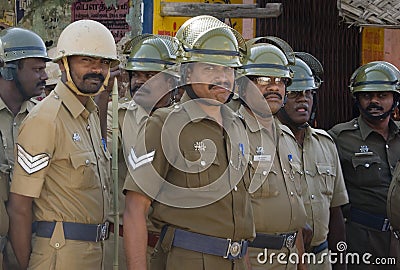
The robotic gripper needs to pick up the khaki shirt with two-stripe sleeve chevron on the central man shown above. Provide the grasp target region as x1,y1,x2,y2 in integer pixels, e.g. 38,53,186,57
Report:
124,96,254,241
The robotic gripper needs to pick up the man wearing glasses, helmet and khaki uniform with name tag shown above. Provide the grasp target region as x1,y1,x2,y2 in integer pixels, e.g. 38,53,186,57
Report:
238,37,306,269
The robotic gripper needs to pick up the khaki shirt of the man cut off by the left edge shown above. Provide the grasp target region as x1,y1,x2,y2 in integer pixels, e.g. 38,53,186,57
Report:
0,98,37,236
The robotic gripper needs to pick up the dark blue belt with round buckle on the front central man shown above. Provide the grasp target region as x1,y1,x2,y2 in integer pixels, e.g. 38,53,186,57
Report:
161,229,248,260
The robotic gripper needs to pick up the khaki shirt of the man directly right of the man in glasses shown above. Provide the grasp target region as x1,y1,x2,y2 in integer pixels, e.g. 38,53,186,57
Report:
299,127,349,246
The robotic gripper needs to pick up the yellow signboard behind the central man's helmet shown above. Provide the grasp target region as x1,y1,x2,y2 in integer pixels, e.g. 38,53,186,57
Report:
153,0,254,39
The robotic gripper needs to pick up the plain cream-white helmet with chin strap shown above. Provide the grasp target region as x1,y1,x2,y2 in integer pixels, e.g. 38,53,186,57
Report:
53,20,119,96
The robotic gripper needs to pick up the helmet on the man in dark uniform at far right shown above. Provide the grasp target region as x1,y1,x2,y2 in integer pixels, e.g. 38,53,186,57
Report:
349,61,400,96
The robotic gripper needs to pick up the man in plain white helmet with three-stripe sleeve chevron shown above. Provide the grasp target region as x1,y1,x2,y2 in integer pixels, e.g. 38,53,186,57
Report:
8,20,118,269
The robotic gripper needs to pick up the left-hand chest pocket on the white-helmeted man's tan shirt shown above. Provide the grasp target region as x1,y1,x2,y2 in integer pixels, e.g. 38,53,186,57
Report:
70,151,99,189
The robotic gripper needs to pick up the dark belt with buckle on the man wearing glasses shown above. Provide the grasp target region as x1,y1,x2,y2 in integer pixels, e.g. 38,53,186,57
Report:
249,232,297,250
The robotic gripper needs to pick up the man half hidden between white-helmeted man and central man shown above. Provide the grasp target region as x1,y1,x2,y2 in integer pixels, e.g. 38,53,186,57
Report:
105,34,179,269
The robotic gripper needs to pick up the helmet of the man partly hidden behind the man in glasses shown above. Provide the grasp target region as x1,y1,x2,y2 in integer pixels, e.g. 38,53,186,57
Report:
287,52,324,91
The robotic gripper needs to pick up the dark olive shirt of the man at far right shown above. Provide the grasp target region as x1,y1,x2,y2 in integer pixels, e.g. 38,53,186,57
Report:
329,117,400,216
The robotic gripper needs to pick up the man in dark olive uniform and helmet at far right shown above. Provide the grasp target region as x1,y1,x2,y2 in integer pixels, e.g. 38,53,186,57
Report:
329,61,400,269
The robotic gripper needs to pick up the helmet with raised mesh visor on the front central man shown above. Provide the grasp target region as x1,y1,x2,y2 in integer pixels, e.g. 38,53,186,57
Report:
175,15,246,67
